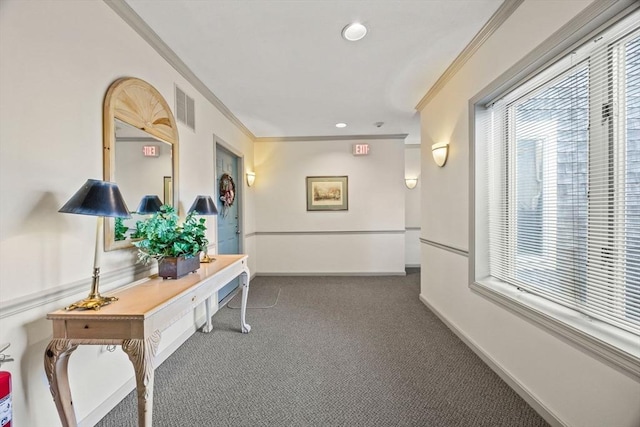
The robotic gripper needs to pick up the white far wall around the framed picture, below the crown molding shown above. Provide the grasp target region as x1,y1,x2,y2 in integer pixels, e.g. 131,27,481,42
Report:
255,139,405,274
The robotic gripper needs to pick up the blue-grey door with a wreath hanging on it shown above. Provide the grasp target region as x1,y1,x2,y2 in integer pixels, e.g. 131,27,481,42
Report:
216,144,241,302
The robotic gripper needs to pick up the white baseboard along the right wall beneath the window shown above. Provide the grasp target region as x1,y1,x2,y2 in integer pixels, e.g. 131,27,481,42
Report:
420,294,567,427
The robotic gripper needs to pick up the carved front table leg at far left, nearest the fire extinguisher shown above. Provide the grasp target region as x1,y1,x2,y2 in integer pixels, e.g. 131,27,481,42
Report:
44,338,78,427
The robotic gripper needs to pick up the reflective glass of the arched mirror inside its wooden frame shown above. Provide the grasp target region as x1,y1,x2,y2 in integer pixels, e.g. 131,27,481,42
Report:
113,119,173,242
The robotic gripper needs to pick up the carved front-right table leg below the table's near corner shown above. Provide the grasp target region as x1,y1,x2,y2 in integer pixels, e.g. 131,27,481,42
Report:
122,331,160,427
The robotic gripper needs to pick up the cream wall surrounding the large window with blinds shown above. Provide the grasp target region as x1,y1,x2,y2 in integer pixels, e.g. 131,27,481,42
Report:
421,0,640,427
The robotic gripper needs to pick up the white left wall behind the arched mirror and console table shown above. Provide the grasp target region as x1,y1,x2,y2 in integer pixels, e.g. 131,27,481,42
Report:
0,0,255,427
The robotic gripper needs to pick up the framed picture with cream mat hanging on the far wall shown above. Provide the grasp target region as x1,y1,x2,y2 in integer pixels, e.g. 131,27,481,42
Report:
307,176,349,211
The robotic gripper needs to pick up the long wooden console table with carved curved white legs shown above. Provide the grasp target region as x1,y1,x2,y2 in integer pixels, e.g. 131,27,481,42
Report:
44,255,251,427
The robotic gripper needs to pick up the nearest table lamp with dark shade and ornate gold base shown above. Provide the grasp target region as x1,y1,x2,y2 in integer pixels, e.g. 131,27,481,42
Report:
58,179,131,310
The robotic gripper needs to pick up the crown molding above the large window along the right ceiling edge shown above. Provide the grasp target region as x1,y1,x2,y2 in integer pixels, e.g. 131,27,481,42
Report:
416,0,524,111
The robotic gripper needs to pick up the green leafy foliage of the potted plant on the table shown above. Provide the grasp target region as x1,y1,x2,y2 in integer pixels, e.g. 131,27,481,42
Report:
133,205,209,264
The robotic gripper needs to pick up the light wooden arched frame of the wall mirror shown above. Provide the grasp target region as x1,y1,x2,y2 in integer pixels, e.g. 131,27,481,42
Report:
102,77,179,251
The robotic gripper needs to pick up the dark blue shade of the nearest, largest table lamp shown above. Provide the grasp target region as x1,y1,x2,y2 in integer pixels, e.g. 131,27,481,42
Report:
58,179,131,218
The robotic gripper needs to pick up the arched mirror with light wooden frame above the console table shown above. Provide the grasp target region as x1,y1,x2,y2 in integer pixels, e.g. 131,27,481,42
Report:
103,77,178,251
